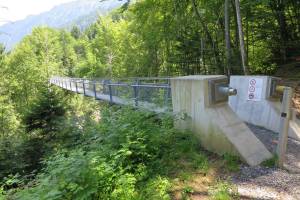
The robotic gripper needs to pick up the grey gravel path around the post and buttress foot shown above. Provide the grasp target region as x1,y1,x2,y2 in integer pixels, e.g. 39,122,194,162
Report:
233,125,300,200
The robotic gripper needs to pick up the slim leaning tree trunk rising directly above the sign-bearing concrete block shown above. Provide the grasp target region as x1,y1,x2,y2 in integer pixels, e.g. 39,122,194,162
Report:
235,0,249,75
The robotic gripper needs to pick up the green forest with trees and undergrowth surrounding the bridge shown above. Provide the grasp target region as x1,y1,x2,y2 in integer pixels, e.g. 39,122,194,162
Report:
0,0,300,200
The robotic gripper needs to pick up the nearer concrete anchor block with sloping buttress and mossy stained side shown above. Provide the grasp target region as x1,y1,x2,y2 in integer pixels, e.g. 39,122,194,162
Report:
171,76,272,165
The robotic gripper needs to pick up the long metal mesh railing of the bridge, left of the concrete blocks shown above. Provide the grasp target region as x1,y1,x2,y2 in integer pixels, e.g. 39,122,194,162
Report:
50,77,172,112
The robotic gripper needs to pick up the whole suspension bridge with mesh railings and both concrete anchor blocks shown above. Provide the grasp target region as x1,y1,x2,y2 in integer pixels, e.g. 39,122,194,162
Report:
50,75,300,168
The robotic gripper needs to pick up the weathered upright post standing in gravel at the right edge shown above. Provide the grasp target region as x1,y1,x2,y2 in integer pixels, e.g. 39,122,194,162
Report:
277,87,293,168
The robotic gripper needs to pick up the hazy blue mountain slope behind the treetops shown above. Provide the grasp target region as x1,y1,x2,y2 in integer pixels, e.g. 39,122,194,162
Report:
0,0,126,50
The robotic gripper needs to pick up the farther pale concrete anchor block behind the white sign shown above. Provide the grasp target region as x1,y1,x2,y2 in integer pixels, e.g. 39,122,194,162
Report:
229,76,300,140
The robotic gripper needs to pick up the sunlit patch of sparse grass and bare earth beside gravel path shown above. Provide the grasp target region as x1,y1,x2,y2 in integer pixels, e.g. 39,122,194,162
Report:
171,153,240,200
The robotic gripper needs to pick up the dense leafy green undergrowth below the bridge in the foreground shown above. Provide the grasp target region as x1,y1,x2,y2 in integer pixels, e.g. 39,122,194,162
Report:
0,98,239,200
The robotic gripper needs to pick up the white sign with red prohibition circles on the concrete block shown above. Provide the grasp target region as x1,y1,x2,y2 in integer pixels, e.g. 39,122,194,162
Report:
248,78,263,101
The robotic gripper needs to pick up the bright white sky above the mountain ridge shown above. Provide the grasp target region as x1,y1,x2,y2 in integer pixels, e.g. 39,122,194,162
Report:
0,0,74,25
